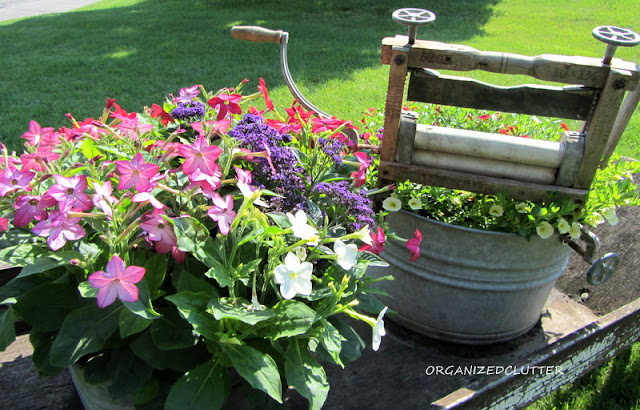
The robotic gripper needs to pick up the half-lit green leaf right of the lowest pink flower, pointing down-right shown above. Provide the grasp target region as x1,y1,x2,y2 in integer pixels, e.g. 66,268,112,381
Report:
166,292,220,341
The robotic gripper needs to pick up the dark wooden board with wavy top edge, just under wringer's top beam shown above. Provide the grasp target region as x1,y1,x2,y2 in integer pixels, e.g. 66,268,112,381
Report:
407,70,596,121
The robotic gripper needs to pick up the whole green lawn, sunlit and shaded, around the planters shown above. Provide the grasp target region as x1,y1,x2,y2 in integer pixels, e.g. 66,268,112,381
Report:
0,0,640,409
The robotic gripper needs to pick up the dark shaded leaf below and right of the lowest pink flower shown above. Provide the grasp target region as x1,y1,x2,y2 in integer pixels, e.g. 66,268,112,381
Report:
151,306,199,350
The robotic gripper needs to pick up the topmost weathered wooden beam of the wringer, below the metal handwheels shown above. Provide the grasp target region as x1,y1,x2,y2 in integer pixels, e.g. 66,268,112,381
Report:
382,36,640,90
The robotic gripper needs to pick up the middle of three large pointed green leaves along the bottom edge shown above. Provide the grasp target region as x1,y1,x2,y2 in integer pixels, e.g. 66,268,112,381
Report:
224,344,282,403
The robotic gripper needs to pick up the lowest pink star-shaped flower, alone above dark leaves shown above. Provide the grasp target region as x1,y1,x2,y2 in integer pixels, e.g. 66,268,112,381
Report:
87,255,145,308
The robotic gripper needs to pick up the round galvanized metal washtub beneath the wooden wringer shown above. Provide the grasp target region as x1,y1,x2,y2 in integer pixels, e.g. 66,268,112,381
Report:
368,211,571,344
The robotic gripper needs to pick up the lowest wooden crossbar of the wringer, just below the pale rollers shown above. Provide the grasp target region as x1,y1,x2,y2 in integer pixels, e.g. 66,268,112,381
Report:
378,161,588,202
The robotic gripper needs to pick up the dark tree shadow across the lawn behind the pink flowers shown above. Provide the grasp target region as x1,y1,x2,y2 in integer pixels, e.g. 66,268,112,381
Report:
0,0,498,149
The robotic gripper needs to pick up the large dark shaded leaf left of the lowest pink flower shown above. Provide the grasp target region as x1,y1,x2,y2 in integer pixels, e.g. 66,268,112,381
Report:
15,282,81,332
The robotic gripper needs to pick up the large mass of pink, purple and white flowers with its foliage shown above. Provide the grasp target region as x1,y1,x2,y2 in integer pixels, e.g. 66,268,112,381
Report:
0,80,416,408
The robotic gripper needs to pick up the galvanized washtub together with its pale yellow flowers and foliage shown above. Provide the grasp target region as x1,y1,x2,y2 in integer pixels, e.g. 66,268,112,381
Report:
365,104,640,344
